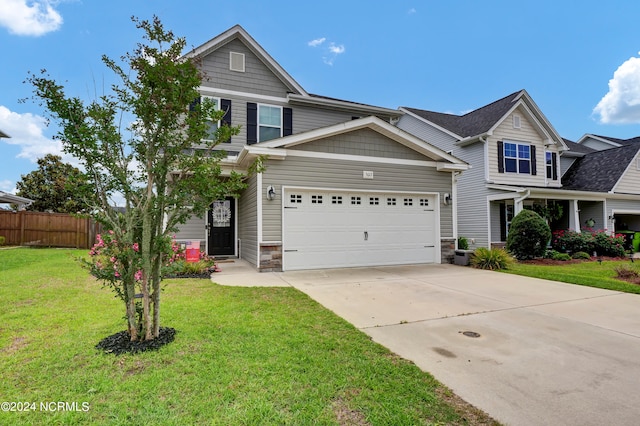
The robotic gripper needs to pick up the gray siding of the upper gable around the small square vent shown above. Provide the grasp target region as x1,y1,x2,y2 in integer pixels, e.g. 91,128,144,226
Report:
202,39,292,98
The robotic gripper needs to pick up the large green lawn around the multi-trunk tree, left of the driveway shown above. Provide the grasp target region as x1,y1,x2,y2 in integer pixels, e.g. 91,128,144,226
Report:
0,248,493,425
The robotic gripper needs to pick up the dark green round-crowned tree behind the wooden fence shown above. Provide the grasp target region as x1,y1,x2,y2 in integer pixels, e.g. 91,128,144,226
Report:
16,154,93,213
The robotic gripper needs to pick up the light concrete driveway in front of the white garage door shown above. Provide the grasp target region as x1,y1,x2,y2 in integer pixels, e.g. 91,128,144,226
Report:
213,261,640,425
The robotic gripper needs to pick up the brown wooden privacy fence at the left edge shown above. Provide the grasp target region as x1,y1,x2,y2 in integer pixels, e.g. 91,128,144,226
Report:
0,211,100,248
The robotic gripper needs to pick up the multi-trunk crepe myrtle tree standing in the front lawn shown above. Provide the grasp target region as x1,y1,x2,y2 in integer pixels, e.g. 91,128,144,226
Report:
27,17,262,341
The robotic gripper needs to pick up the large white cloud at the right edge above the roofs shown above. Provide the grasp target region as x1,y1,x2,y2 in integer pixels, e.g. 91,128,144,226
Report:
593,52,640,124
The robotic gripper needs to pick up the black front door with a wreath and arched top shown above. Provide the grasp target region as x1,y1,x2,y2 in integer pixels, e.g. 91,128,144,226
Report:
207,198,236,256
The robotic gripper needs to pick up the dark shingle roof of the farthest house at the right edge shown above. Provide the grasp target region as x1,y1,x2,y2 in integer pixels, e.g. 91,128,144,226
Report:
562,143,640,192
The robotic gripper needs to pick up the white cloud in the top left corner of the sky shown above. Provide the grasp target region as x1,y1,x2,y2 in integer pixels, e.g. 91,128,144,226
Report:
0,0,62,37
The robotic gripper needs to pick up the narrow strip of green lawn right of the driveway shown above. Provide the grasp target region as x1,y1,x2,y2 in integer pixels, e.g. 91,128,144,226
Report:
502,260,640,294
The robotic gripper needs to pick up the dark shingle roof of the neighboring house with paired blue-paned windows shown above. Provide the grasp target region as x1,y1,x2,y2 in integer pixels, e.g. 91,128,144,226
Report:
403,90,523,138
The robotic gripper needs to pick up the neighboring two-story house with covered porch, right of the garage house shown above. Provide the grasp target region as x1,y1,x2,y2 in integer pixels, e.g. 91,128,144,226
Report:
398,90,624,248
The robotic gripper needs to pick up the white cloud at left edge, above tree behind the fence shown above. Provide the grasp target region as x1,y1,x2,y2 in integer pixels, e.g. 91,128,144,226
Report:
0,105,65,163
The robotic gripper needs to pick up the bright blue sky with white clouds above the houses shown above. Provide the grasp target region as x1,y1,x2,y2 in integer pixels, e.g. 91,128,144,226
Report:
0,0,640,192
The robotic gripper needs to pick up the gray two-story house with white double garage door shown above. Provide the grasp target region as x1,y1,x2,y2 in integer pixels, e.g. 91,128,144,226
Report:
176,26,468,270
